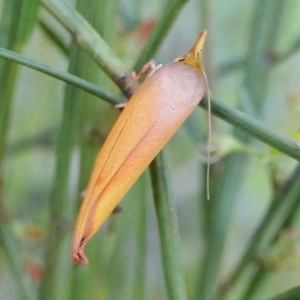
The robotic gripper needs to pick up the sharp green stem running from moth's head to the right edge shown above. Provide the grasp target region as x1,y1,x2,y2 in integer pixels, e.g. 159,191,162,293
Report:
199,97,300,161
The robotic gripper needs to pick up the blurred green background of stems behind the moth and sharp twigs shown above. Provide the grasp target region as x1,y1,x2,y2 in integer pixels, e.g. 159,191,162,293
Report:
0,0,300,300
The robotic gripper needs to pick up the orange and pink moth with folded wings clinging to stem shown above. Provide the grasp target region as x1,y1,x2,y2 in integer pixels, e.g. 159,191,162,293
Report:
72,31,208,265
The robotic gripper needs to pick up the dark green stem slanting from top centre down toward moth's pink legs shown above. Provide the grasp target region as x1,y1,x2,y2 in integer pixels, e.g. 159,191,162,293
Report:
133,0,187,71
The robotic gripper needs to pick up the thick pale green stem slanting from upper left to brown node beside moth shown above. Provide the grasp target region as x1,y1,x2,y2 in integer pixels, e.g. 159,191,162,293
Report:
40,0,137,96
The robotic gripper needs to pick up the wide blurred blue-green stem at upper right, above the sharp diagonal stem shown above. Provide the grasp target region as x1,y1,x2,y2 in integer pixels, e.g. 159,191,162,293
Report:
242,0,286,116
